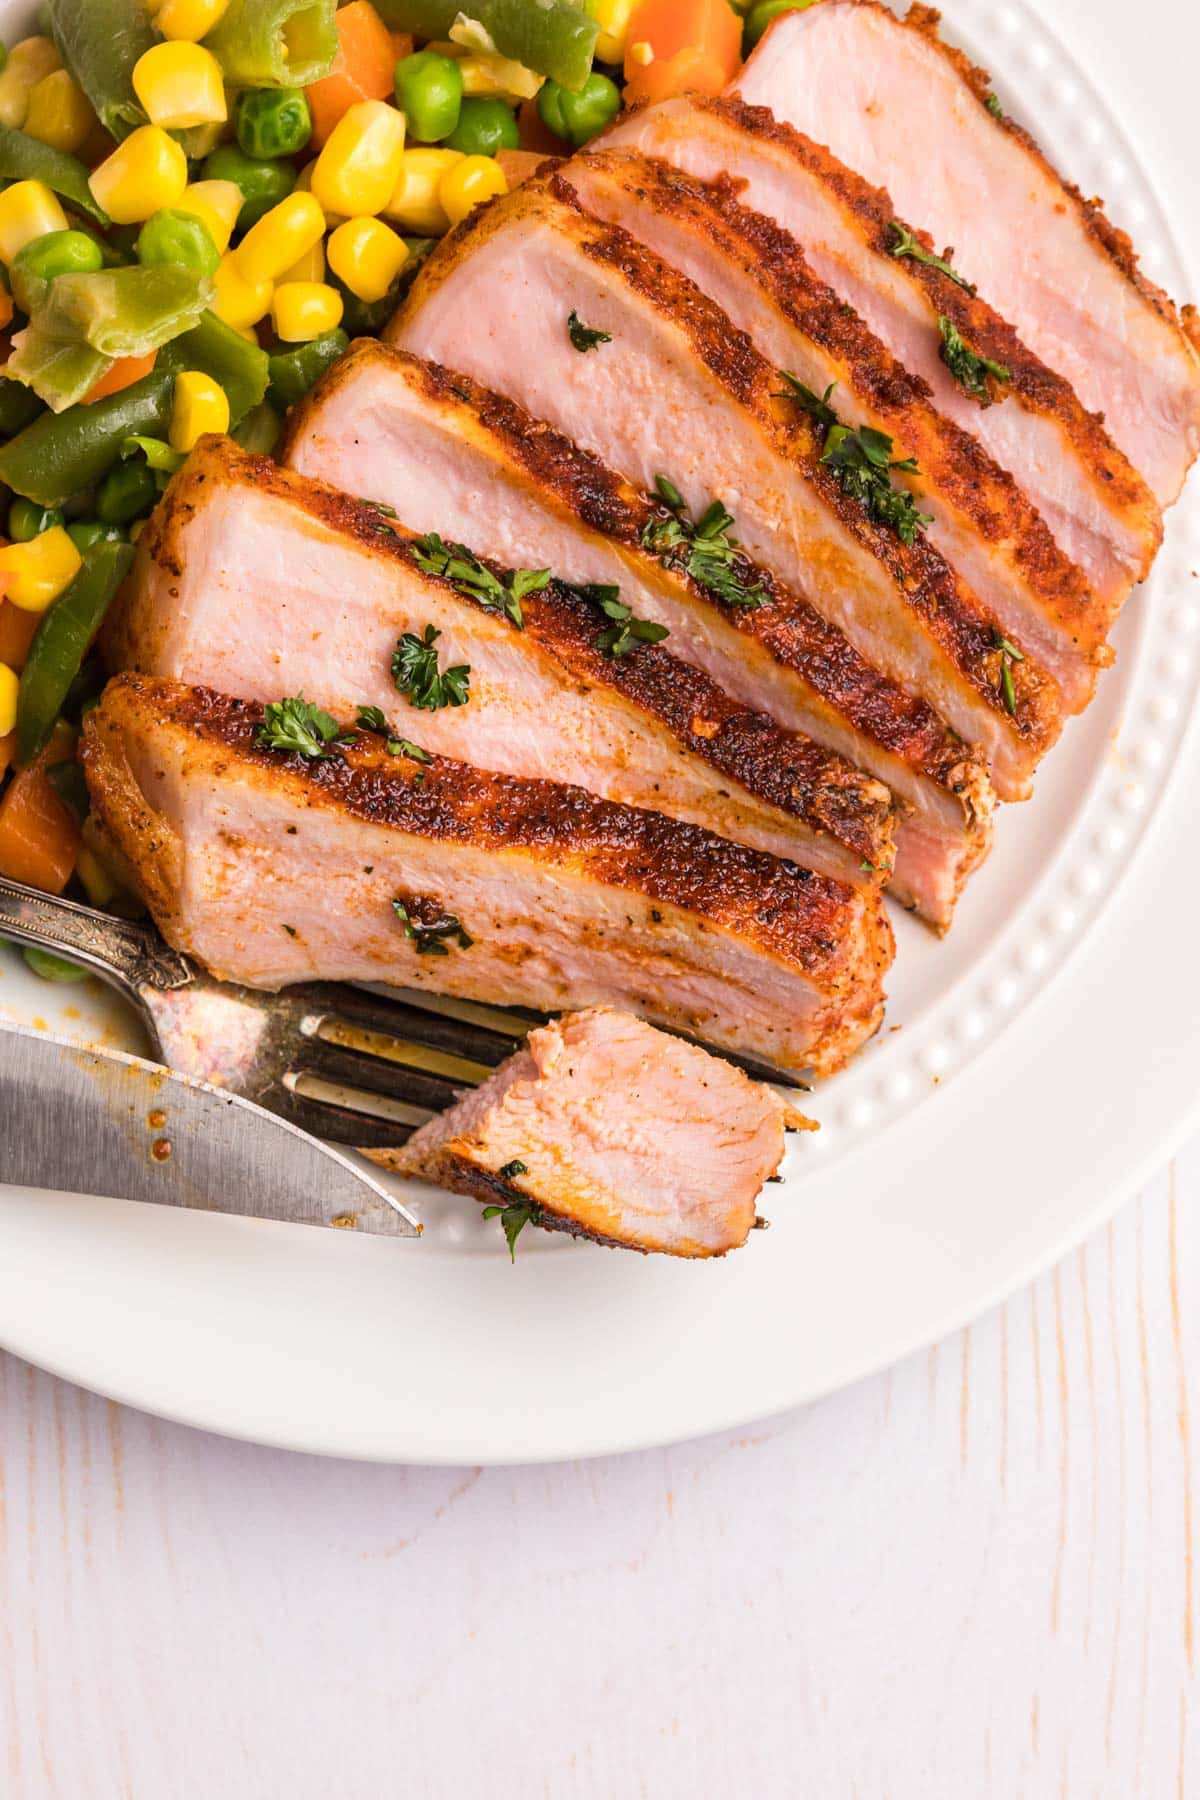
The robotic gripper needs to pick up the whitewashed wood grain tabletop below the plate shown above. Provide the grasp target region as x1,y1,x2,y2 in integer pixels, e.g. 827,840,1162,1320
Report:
0,1145,1200,1800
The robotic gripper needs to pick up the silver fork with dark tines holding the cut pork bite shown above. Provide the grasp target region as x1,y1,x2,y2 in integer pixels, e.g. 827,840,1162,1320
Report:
0,877,804,1150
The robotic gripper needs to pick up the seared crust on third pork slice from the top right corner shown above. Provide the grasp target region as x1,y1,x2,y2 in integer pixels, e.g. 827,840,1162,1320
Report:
563,149,1112,668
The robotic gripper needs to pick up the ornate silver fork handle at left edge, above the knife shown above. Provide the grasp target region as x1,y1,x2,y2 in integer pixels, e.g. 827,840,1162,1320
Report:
0,875,194,999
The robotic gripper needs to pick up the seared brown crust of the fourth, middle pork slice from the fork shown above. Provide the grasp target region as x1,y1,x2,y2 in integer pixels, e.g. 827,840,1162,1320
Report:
413,186,1061,761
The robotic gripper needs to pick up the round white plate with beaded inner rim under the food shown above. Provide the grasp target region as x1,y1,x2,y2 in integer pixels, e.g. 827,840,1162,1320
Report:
0,0,1200,1463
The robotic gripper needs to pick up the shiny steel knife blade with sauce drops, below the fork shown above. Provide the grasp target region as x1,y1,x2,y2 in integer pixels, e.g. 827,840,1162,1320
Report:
0,1024,421,1237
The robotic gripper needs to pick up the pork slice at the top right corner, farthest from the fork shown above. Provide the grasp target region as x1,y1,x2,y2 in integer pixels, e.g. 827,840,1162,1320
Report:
734,0,1200,506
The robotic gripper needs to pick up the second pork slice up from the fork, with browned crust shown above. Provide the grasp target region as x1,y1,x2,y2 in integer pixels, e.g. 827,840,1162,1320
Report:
104,437,894,882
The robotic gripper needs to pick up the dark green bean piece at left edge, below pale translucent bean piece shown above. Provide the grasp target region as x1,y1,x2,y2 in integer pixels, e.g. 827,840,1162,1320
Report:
0,365,173,506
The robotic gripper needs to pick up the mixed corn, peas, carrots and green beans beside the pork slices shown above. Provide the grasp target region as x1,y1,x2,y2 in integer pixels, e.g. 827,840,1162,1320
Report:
0,0,810,977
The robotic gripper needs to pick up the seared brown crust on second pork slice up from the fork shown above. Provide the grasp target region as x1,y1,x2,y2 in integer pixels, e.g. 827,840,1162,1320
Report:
129,437,896,871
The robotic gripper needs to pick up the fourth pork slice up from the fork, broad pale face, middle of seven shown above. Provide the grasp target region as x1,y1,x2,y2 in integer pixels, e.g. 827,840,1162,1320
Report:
389,175,1061,799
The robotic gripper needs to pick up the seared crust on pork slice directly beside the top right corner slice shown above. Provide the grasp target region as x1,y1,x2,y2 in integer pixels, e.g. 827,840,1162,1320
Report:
694,91,1162,565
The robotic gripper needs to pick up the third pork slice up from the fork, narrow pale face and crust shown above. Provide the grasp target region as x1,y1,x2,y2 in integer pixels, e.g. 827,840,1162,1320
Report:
284,338,993,929
